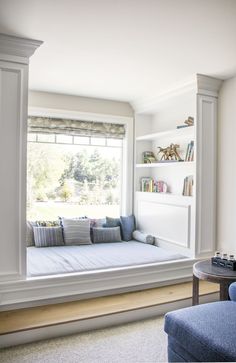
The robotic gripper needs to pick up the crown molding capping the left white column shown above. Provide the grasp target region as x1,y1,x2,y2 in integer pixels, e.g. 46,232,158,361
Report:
0,33,43,64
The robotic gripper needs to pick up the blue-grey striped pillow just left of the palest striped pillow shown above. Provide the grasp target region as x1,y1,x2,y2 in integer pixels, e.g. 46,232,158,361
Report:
33,227,64,247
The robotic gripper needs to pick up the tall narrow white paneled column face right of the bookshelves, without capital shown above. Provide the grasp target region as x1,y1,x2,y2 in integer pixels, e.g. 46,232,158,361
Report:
196,95,217,256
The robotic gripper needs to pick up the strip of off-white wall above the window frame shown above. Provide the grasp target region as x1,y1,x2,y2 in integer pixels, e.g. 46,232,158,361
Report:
29,91,133,117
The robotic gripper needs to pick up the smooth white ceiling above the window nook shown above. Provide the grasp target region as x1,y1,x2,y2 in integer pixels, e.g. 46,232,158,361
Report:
0,0,236,111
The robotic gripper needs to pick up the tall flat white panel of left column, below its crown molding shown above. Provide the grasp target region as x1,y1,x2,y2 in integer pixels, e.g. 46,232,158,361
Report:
0,62,24,279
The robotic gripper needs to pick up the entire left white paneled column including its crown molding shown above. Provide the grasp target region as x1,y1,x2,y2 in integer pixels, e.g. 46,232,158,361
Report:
0,34,41,281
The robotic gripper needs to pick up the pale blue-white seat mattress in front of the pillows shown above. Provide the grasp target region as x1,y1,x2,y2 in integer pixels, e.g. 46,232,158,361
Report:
27,241,184,277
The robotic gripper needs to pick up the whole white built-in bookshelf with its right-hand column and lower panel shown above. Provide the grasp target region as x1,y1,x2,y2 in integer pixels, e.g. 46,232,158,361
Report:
134,75,221,258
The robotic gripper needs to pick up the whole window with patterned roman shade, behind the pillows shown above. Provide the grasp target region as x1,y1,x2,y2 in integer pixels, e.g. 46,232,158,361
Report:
27,117,124,221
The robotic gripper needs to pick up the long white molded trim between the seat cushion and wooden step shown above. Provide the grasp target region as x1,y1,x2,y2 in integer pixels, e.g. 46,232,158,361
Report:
0,259,196,310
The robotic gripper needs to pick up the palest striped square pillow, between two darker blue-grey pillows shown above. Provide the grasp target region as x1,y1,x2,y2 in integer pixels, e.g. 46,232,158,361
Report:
61,218,92,245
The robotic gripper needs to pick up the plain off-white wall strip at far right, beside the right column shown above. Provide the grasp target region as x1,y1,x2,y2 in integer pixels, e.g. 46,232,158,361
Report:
217,77,236,254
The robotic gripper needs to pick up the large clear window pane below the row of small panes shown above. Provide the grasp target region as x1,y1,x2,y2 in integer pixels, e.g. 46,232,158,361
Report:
27,144,122,221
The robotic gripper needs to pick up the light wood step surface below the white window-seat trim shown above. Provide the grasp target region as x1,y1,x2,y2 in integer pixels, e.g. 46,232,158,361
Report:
0,281,219,335
